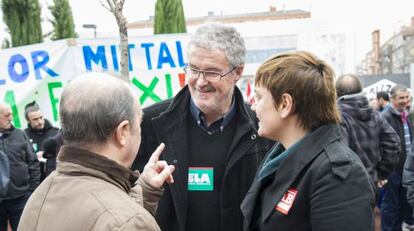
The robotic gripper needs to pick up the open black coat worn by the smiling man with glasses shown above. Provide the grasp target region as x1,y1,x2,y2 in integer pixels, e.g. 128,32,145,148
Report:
133,86,273,231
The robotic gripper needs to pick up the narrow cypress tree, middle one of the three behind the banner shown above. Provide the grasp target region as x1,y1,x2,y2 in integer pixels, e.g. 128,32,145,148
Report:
49,0,77,40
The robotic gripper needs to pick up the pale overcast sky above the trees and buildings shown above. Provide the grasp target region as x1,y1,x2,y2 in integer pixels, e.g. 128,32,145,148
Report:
0,0,414,66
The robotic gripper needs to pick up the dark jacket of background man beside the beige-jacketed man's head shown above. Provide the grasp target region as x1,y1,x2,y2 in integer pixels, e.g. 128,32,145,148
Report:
24,119,59,152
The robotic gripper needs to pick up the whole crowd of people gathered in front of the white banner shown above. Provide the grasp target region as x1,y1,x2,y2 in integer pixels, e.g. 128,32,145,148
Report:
0,23,414,231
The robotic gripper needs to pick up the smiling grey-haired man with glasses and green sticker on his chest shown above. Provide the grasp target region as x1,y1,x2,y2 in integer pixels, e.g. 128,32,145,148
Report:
133,23,272,231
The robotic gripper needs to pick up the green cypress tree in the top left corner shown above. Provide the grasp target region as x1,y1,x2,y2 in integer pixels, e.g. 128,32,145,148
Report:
1,0,43,47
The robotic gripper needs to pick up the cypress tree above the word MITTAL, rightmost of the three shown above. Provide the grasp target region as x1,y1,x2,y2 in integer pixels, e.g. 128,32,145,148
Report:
154,0,187,34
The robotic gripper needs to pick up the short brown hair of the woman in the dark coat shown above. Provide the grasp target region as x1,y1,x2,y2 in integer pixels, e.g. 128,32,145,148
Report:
254,51,340,130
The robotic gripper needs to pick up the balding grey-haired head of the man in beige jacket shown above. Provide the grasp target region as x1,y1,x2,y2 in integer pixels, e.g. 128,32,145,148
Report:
60,73,141,144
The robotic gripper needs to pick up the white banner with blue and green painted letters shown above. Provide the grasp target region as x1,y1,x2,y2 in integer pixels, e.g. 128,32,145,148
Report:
0,34,189,127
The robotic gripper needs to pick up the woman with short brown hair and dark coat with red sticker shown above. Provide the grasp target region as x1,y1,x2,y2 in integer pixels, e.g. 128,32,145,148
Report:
241,51,375,231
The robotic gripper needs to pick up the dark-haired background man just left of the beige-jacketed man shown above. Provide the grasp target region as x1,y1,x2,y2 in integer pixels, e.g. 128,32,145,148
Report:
24,101,59,181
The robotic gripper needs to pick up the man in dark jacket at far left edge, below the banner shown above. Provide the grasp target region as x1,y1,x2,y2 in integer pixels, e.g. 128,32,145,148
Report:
0,103,40,231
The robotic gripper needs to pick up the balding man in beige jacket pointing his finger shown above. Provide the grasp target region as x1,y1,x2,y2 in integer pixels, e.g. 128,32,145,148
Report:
19,73,174,231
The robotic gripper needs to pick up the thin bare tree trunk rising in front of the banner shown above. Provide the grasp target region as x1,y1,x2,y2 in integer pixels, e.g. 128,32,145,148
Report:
100,0,129,81
